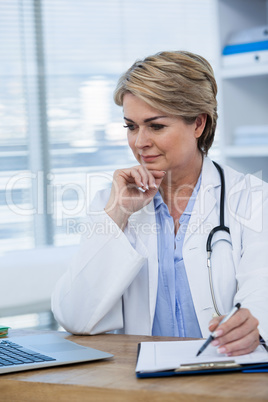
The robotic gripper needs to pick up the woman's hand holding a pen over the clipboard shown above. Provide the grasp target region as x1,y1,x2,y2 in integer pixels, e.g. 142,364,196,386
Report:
209,308,259,356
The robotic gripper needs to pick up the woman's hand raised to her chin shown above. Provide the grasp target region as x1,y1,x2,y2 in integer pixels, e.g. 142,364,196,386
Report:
105,165,166,230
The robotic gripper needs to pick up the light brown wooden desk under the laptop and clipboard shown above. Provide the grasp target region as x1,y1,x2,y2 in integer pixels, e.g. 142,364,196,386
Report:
0,331,268,402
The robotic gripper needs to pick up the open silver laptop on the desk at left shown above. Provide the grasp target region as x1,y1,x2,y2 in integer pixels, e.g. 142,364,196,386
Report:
0,333,113,374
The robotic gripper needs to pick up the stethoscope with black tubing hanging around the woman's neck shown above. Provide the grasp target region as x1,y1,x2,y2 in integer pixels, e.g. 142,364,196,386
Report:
206,161,230,316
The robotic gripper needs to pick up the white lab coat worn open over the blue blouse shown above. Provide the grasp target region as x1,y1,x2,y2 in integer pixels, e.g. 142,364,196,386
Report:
52,158,268,341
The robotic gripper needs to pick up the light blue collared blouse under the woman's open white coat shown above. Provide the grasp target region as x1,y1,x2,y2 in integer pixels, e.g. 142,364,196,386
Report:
152,175,202,338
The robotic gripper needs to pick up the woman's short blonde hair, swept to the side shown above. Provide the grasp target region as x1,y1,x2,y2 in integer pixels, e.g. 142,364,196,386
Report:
114,51,218,155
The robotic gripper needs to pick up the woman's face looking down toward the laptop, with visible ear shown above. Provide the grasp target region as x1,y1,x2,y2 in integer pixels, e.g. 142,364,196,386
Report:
123,93,206,176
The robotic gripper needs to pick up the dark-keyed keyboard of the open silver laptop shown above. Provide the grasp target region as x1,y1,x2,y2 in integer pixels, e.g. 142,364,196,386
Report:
0,340,56,367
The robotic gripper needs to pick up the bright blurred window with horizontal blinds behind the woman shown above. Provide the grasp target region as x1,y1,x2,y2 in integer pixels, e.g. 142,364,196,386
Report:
0,0,217,249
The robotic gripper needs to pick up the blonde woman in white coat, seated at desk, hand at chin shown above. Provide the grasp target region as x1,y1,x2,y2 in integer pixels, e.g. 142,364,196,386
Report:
52,51,268,356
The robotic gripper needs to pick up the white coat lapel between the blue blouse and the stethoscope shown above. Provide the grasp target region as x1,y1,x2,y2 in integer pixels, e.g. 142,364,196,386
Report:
183,158,221,337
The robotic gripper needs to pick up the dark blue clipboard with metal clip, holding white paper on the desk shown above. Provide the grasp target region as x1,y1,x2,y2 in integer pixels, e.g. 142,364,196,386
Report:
136,341,268,378
